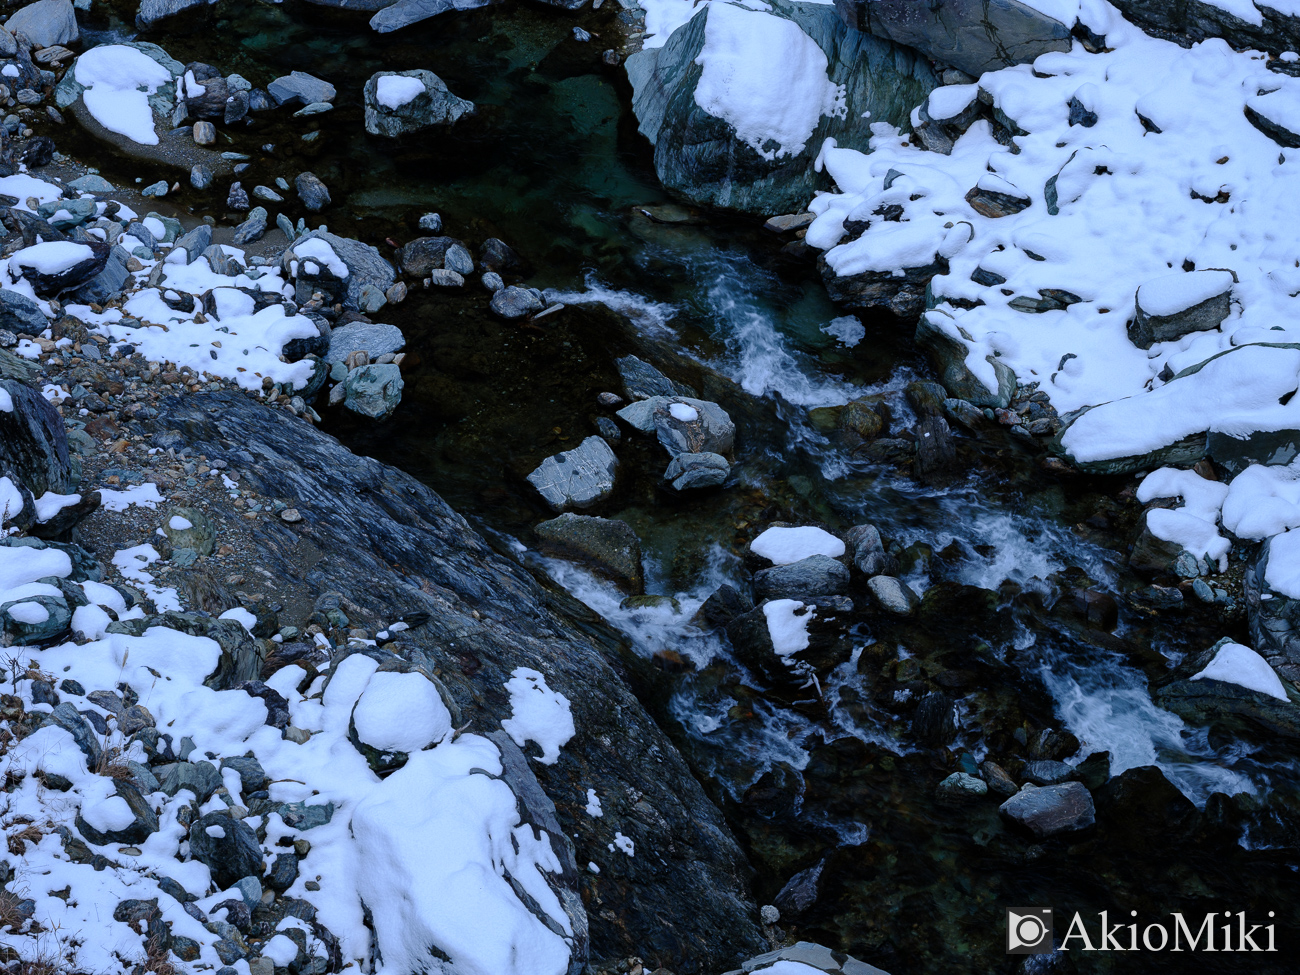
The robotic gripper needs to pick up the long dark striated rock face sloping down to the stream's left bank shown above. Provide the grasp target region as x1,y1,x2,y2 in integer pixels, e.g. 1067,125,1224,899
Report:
147,393,766,971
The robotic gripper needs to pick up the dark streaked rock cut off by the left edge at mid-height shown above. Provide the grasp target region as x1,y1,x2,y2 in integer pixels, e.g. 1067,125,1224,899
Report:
0,380,75,498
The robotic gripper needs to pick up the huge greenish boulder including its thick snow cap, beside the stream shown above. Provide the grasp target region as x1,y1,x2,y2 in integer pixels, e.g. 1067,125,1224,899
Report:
627,0,937,216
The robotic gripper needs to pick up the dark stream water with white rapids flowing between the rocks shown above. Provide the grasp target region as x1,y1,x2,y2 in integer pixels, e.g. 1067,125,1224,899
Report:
65,0,1300,975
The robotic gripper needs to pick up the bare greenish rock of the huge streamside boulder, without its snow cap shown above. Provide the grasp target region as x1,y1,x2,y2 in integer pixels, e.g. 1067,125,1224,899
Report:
627,0,939,216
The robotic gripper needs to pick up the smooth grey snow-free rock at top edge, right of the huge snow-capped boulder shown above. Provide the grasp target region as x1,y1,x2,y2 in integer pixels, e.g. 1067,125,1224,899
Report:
835,0,1074,78
